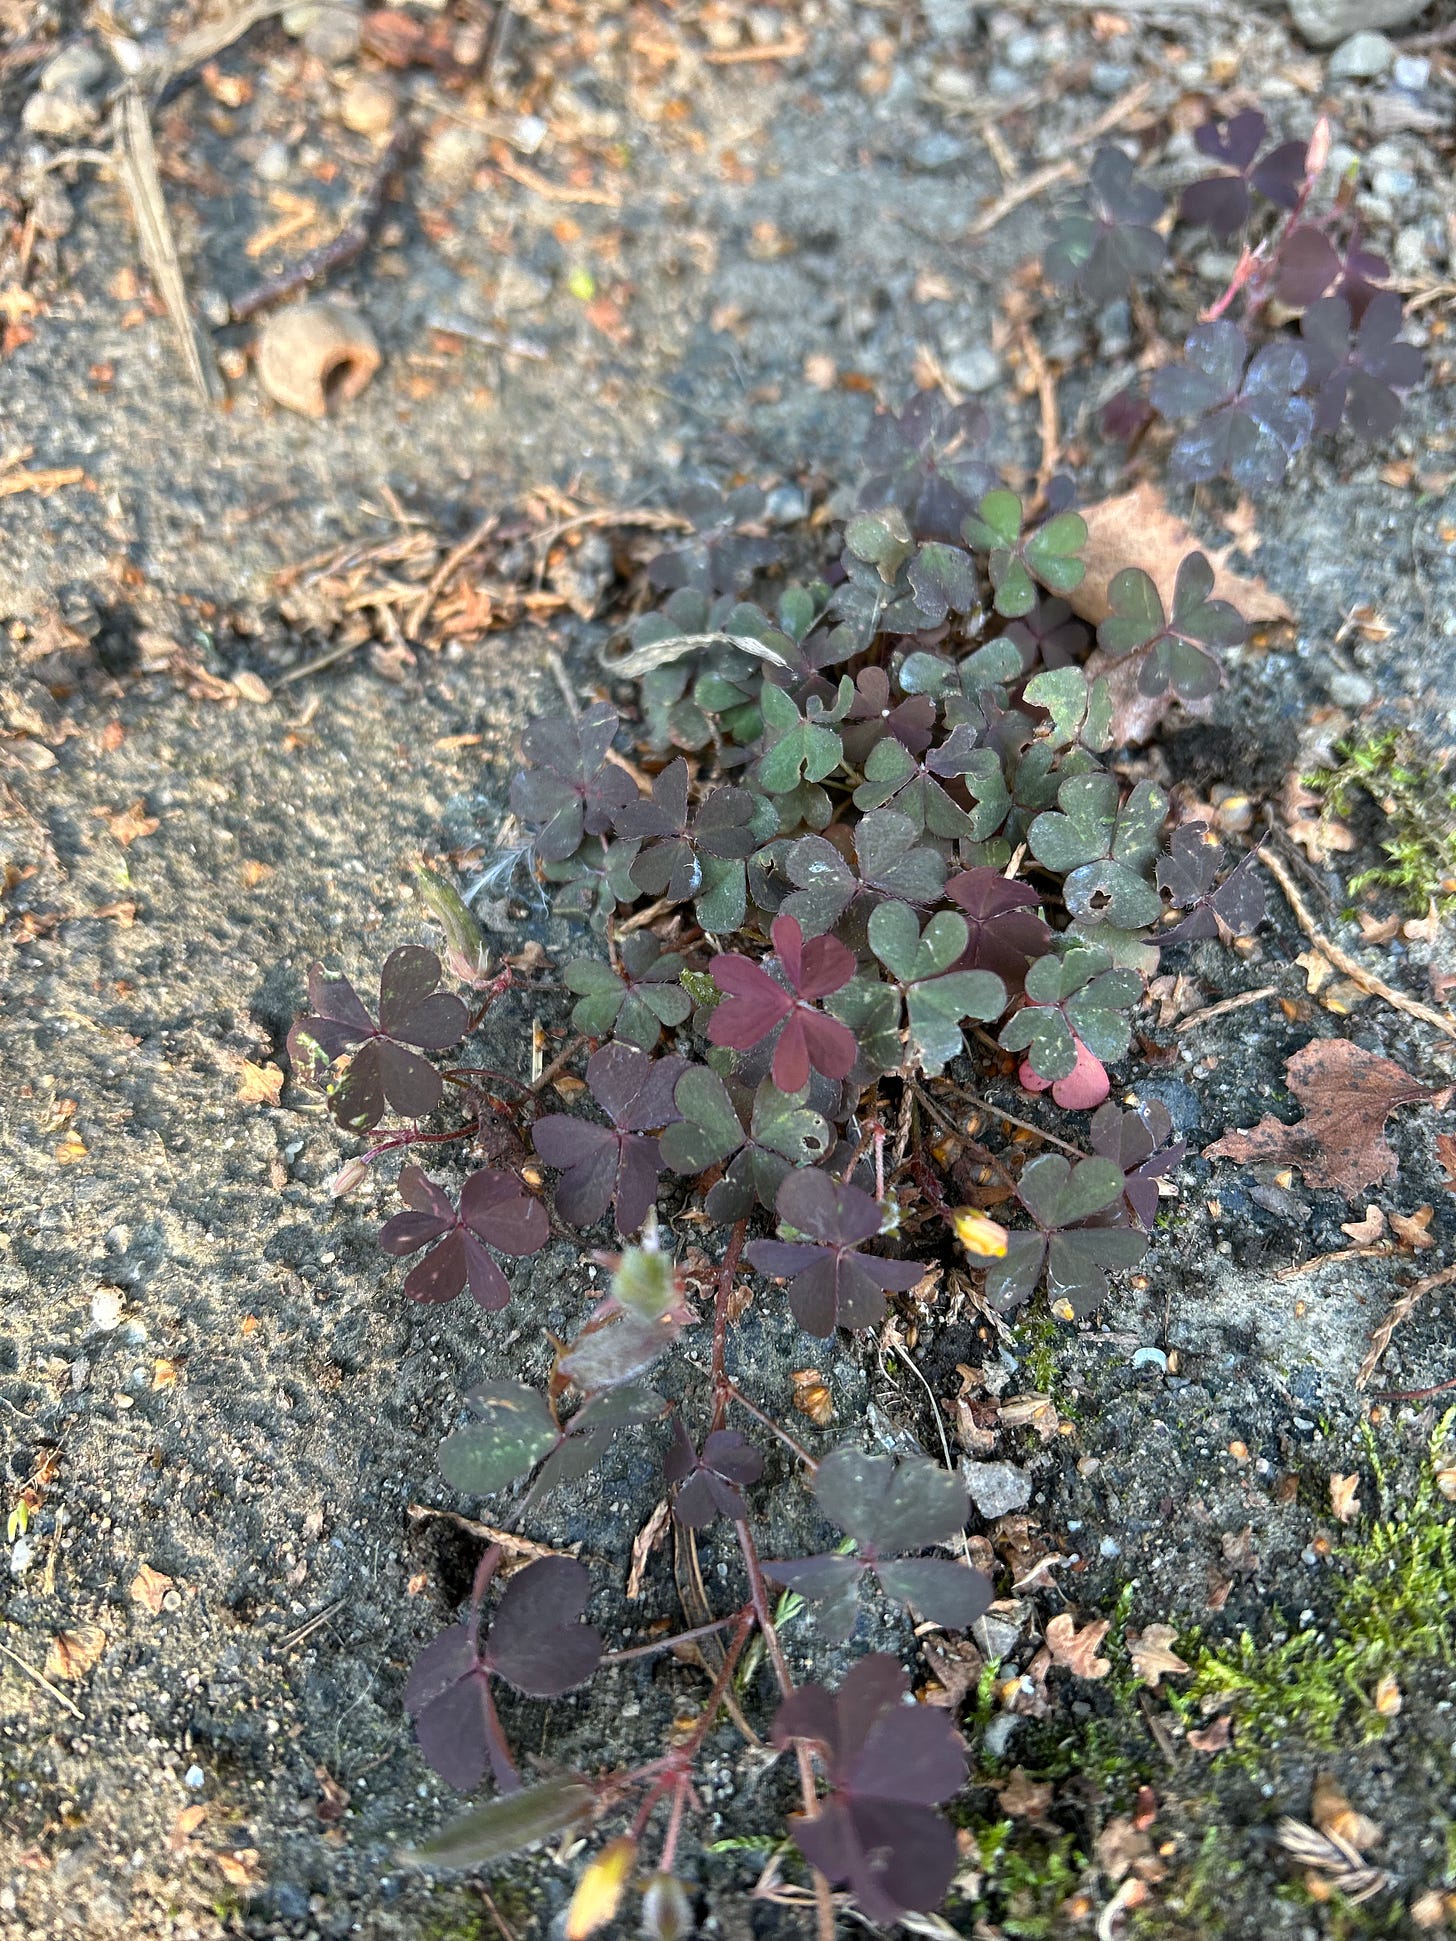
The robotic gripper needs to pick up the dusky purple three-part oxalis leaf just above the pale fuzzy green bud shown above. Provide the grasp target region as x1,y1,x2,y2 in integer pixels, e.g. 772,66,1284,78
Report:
532,1044,687,1234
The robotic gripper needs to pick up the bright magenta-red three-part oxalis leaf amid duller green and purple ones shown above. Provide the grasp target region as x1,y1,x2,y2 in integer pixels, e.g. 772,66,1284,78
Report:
709,916,856,1093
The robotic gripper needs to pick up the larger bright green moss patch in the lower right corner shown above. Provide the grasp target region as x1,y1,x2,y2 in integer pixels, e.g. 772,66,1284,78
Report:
1173,1411,1456,1759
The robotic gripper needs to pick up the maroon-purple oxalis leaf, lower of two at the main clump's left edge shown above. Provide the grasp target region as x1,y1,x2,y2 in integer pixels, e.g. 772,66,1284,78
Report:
379,1167,551,1310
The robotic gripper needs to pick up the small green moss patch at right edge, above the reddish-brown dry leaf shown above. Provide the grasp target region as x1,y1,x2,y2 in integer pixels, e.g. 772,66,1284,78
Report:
1305,730,1456,916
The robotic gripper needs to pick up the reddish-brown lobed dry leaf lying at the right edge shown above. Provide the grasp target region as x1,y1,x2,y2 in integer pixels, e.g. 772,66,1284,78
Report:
1204,1038,1433,1200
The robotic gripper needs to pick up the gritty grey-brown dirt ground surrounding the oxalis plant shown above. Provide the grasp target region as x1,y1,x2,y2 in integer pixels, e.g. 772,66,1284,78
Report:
0,0,1456,1941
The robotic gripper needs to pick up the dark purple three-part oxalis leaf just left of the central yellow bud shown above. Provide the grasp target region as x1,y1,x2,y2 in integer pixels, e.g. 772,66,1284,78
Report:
747,1168,926,1335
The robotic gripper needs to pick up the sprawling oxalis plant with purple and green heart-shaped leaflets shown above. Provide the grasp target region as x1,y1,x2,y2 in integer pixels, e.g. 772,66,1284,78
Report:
289,115,1419,1941
